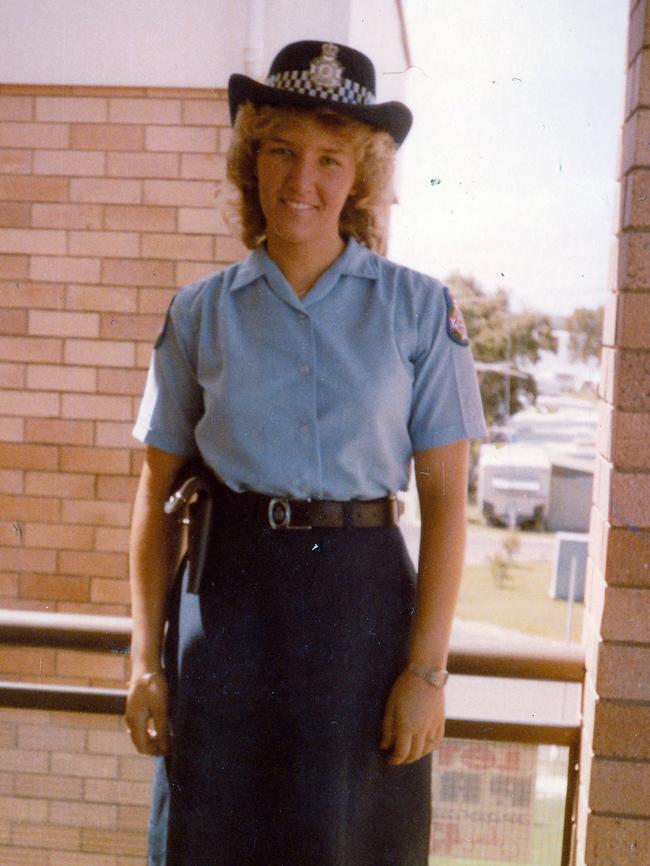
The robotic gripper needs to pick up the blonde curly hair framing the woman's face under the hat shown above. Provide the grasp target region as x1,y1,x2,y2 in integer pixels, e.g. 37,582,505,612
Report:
224,102,397,254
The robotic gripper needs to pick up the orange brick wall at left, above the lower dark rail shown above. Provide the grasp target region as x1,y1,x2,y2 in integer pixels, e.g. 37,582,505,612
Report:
0,85,243,685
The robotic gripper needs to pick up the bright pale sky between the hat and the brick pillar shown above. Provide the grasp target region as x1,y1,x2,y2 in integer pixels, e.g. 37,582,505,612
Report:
389,0,629,315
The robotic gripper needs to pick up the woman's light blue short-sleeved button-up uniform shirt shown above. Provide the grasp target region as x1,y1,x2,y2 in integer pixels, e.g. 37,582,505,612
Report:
134,240,485,499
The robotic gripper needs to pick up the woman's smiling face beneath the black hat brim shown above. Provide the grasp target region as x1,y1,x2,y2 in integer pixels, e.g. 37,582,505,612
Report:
257,116,355,249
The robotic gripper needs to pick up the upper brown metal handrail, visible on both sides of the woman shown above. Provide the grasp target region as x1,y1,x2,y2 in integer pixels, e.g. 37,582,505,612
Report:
0,609,585,683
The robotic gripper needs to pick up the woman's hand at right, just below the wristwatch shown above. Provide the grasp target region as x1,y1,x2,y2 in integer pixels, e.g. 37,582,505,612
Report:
379,670,445,766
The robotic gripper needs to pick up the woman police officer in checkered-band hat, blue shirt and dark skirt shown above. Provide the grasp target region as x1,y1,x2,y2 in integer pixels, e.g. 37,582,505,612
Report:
126,42,484,866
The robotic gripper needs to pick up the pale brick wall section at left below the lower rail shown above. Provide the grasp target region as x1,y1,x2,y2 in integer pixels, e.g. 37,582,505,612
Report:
0,709,152,866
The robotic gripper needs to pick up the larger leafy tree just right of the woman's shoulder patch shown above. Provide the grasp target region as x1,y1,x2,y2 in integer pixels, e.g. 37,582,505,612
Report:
446,273,557,424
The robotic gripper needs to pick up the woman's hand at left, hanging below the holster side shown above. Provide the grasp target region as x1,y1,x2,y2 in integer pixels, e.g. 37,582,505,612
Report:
124,671,169,755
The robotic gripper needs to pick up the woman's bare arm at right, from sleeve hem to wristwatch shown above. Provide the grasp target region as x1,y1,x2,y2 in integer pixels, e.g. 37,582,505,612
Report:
409,442,467,670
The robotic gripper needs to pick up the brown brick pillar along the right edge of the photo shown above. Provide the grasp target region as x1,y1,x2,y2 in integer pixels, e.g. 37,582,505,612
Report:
578,0,650,866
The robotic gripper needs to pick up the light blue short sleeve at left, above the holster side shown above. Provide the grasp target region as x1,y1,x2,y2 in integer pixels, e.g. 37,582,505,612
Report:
133,301,203,455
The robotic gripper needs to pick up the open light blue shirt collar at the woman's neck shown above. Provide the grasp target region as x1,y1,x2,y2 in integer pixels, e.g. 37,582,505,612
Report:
230,237,377,306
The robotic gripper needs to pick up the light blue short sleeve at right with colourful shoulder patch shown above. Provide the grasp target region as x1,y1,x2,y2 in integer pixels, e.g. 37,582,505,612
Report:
409,282,486,451
